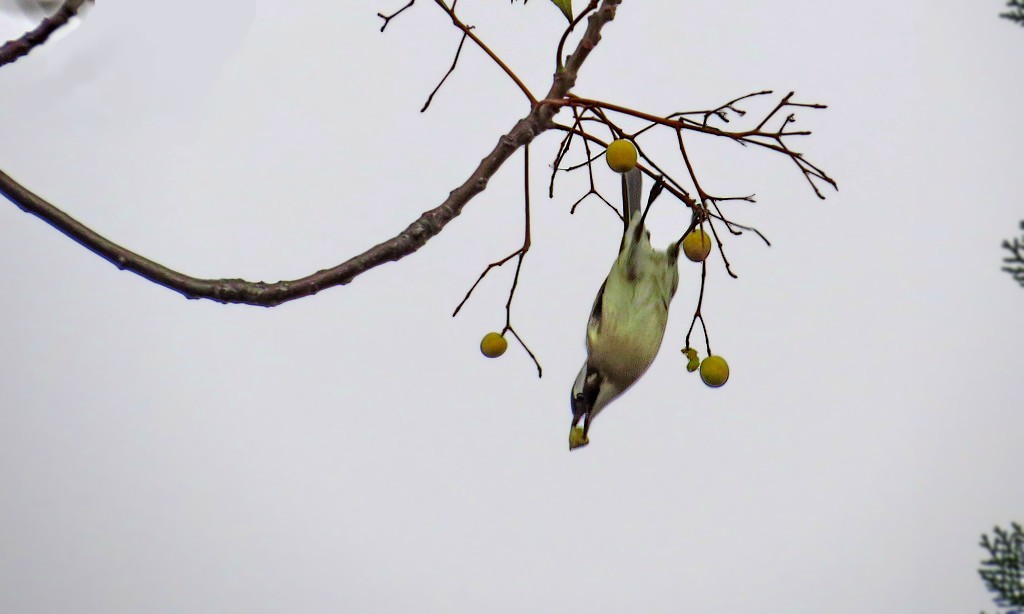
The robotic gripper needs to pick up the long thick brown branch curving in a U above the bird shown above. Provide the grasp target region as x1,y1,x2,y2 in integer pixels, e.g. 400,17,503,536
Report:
0,0,621,307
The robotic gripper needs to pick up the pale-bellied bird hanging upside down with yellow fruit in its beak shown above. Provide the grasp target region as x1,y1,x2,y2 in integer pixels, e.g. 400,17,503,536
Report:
569,168,696,450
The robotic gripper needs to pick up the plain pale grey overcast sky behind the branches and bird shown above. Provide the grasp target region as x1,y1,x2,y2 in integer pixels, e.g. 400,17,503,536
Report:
0,0,1024,614
